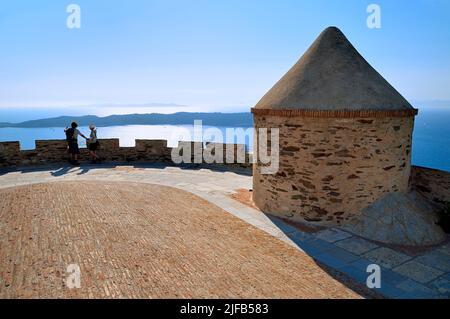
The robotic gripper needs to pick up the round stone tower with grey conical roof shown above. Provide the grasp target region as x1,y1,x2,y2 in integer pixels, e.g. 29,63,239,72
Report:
252,27,417,225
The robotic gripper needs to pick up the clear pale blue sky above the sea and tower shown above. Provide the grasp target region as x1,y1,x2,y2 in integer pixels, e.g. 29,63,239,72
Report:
0,0,450,111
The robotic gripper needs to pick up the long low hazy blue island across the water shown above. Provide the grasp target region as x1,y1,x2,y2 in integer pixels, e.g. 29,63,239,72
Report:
0,112,253,128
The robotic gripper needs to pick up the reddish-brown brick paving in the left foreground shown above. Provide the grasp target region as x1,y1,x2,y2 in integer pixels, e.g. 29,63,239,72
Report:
0,181,360,298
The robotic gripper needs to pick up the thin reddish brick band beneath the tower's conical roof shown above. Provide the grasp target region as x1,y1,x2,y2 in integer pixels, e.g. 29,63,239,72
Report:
251,108,419,118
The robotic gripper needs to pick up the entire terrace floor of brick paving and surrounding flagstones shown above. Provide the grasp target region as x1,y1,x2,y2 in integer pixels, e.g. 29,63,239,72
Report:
0,165,450,298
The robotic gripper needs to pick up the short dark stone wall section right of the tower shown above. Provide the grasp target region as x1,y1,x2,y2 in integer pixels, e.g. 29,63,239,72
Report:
411,166,450,205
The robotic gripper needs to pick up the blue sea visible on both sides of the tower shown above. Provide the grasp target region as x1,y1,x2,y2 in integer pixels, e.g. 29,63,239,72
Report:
0,106,450,172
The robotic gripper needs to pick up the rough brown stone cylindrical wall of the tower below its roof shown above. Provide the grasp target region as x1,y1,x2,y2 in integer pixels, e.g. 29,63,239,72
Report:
253,115,414,224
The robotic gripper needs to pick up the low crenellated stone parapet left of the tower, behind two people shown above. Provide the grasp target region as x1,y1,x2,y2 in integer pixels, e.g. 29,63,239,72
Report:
0,138,251,167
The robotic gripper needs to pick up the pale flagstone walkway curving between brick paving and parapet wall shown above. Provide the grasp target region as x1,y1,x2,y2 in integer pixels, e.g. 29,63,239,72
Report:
0,165,450,298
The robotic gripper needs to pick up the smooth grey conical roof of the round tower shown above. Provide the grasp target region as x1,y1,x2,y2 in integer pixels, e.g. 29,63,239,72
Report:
254,27,414,111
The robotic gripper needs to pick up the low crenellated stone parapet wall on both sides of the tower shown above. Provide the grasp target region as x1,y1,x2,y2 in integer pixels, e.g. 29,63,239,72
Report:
0,138,450,208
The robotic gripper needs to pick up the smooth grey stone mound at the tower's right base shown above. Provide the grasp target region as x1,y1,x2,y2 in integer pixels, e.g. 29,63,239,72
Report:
344,192,446,246
